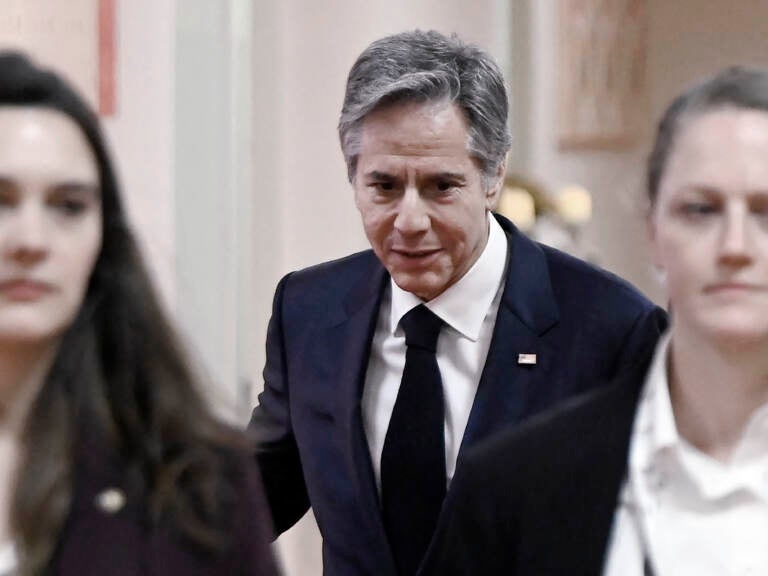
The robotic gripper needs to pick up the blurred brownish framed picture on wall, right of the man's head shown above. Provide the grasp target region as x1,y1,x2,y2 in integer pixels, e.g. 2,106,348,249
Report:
557,0,648,149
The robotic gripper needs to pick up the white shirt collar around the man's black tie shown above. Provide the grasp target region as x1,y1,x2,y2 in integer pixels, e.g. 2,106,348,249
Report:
389,215,507,342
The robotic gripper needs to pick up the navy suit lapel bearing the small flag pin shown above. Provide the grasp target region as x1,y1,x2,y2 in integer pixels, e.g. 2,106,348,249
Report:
459,216,559,460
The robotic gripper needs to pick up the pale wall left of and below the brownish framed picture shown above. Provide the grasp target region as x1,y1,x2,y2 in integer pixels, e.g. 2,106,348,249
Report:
524,0,656,302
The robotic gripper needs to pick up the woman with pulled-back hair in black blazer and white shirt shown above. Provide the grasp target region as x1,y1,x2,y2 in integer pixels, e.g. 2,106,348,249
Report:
425,68,768,576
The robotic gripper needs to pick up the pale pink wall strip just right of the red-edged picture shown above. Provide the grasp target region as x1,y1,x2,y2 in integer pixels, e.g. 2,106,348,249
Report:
104,0,176,309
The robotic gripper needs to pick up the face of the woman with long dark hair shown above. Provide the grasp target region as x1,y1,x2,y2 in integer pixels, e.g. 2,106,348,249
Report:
0,106,102,342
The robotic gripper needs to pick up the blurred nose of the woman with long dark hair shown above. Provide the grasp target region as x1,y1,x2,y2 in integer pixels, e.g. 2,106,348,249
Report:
0,205,49,264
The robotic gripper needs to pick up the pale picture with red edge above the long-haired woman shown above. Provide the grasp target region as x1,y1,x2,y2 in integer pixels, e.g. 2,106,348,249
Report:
0,0,117,116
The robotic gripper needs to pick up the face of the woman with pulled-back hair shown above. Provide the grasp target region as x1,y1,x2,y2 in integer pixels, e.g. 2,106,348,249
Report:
650,108,768,345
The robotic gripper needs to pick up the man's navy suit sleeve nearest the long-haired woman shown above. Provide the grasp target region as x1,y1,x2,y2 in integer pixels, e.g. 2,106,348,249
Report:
248,275,309,534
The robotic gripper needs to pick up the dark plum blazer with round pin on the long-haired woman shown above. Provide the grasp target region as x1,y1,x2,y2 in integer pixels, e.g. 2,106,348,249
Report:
45,441,278,576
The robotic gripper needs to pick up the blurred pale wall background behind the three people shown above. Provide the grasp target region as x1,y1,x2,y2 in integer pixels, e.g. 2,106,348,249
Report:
6,0,768,576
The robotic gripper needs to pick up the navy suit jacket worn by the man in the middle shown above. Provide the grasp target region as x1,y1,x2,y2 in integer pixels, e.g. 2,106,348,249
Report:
250,216,666,576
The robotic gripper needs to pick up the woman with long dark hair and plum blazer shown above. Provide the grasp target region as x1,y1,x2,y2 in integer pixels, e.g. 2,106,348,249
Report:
0,53,275,576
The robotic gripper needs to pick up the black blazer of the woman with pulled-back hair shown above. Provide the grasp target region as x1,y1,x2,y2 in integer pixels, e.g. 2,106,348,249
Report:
423,354,648,576
